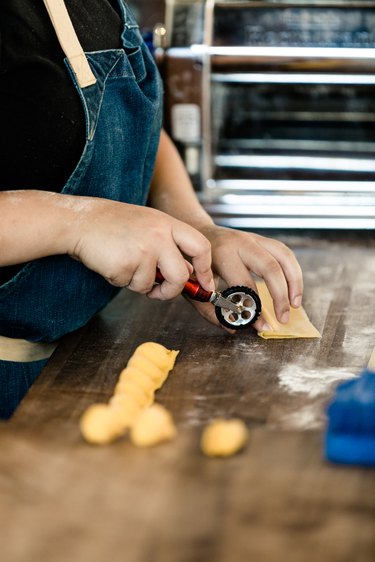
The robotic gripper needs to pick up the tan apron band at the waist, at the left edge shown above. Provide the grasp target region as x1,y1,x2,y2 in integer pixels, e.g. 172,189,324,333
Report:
0,336,58,363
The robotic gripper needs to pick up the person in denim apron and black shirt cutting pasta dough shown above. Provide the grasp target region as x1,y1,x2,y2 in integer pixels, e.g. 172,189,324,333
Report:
0,0,303,418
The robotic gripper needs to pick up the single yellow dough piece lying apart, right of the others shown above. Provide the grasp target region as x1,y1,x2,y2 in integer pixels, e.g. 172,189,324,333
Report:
201,418,249,457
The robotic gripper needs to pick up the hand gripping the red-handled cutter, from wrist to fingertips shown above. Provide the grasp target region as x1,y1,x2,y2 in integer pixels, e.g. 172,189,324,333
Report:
69,198,215,300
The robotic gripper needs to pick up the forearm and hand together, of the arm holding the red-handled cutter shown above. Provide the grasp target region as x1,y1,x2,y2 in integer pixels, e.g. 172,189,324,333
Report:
0,191,214,299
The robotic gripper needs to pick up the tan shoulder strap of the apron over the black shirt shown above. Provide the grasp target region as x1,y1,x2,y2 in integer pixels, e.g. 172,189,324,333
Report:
43,0,96,88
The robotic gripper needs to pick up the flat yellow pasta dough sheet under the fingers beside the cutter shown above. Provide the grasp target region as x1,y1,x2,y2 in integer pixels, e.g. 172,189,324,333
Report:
257,281,321,340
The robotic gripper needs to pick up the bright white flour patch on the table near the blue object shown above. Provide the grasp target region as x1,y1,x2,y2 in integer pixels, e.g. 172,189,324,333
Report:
278,365,357,398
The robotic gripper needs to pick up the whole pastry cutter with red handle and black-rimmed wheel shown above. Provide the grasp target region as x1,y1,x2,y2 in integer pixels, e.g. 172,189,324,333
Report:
155,269,262,330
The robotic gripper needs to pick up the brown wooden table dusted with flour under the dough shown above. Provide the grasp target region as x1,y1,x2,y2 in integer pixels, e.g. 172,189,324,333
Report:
0,230,375,562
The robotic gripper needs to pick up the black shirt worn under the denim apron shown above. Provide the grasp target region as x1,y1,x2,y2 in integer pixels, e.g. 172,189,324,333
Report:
0,0,122,191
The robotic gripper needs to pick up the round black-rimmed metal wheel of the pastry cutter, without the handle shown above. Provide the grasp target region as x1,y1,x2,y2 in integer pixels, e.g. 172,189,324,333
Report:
215,287,262,330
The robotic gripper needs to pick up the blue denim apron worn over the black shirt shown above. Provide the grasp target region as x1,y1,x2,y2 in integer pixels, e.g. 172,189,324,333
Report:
0,0,162,418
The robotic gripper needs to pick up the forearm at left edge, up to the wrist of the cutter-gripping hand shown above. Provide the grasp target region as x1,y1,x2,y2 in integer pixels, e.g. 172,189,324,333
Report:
0,191,77,267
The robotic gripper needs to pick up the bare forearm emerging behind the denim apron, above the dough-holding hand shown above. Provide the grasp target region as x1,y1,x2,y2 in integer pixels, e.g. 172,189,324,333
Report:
149,131,213,230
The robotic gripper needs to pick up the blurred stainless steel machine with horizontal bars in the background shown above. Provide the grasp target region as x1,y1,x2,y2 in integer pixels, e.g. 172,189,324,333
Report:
162,0,375,229
